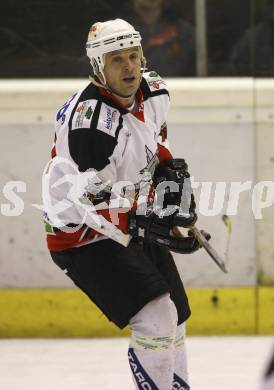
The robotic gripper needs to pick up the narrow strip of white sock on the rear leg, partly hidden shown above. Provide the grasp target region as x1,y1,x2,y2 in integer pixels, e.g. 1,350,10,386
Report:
172,323,190,390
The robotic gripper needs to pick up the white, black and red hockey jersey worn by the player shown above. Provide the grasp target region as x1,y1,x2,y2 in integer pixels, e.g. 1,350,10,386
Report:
43,72,172,251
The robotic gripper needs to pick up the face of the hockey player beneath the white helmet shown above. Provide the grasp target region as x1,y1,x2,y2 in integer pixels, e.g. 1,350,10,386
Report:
104,47,141,102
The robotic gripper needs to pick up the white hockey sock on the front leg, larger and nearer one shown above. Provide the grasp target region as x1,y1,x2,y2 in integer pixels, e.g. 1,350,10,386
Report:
128,294,178,390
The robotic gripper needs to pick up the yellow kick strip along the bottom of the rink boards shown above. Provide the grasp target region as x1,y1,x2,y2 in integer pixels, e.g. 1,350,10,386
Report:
0,287,274,338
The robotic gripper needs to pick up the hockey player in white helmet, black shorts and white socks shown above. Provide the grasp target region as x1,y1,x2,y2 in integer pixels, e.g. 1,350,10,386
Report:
43,19,206,390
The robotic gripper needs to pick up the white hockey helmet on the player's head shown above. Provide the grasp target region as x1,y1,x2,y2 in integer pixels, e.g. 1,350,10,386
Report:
86,19,145,85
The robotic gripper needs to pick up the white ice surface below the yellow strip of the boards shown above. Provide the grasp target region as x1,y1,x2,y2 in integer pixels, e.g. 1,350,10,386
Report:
0,336,273,390
